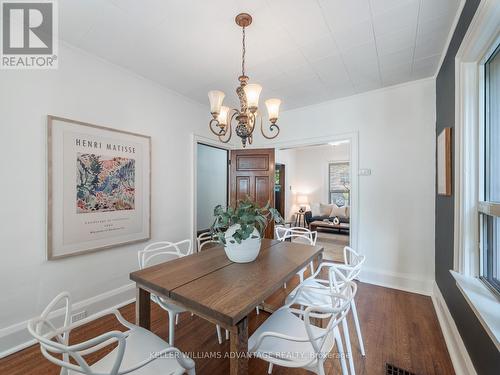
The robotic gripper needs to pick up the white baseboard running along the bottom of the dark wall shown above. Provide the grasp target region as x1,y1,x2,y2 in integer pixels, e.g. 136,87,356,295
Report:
432,282,477,375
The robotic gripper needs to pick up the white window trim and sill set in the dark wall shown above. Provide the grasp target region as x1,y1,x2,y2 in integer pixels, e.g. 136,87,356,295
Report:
454,0,500,350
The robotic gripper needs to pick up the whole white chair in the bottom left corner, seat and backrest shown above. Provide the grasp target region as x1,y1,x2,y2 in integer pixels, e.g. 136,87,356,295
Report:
28,292,195,375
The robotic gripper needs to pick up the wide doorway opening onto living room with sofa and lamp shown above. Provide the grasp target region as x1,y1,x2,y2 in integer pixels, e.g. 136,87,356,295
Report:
276,136,357,261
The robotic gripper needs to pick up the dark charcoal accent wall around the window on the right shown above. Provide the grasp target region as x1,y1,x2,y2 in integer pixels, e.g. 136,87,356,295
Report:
435,0,500,375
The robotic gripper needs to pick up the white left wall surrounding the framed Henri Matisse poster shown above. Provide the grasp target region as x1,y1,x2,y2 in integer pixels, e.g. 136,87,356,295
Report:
0,46,208,352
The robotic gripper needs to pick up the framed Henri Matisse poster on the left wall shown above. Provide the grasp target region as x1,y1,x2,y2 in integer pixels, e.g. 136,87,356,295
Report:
47,116,151,260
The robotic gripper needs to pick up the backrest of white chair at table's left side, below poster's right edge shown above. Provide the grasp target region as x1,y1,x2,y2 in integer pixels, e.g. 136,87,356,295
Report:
137,240,193,269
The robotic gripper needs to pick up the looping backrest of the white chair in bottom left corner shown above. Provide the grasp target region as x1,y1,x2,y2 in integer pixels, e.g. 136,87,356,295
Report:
28,292,126,375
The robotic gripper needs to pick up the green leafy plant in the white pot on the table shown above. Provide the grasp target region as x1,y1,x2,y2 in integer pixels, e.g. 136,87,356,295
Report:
211,197,283,245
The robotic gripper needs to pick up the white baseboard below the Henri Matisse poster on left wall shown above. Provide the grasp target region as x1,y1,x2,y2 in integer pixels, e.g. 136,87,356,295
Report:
0,284,135,358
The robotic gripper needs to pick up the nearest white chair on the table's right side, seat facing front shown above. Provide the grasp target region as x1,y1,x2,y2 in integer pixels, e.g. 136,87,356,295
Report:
248,282,356,375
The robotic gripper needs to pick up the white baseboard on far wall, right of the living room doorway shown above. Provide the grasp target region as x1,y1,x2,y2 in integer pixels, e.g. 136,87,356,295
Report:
360,267,434,296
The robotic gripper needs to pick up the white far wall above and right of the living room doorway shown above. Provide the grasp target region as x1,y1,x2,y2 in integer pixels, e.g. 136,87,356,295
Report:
257,79,436,293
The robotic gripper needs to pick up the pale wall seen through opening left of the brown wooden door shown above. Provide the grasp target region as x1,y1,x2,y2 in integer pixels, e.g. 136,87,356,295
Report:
196,144,228,230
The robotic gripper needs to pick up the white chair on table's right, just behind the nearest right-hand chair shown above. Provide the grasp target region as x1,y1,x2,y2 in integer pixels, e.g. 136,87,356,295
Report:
287,246,365,375
